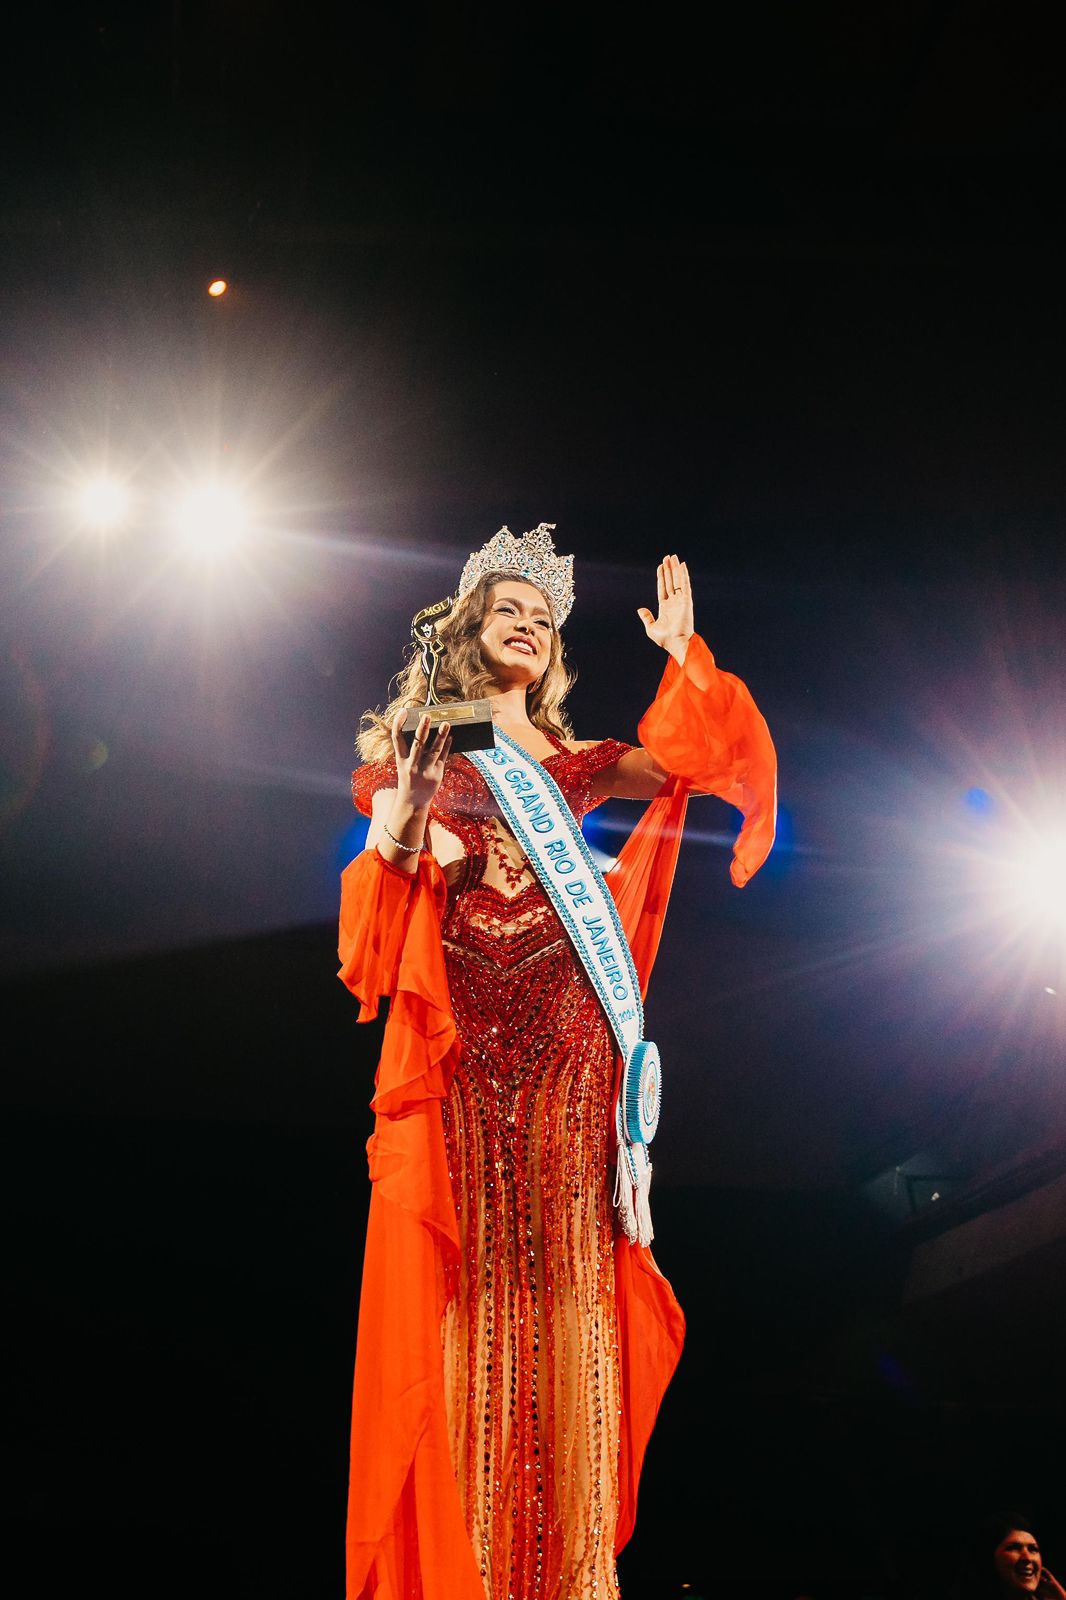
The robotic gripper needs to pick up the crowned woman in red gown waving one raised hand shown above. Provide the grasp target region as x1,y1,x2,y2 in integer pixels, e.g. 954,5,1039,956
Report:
341,523,775,1600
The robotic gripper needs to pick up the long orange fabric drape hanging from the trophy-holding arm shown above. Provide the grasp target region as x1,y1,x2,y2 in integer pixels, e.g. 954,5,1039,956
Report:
339,851,483,1600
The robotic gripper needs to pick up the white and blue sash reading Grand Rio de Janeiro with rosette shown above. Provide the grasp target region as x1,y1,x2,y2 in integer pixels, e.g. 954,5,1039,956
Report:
467,728,663,1245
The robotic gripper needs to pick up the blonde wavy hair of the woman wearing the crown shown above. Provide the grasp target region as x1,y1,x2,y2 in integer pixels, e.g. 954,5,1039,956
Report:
355,573,576,762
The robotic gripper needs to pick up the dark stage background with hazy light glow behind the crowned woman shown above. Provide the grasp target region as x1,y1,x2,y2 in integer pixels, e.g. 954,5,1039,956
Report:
0,0,1066,1600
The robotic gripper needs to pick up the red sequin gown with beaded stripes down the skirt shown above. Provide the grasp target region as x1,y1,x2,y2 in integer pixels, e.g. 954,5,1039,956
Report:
348,741,627,1600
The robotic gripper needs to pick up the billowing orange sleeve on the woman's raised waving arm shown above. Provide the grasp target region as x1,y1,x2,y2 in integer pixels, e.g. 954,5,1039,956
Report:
639,634,778,888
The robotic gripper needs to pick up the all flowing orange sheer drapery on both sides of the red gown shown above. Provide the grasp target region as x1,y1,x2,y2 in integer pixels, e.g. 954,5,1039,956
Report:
339,638,775,1600
